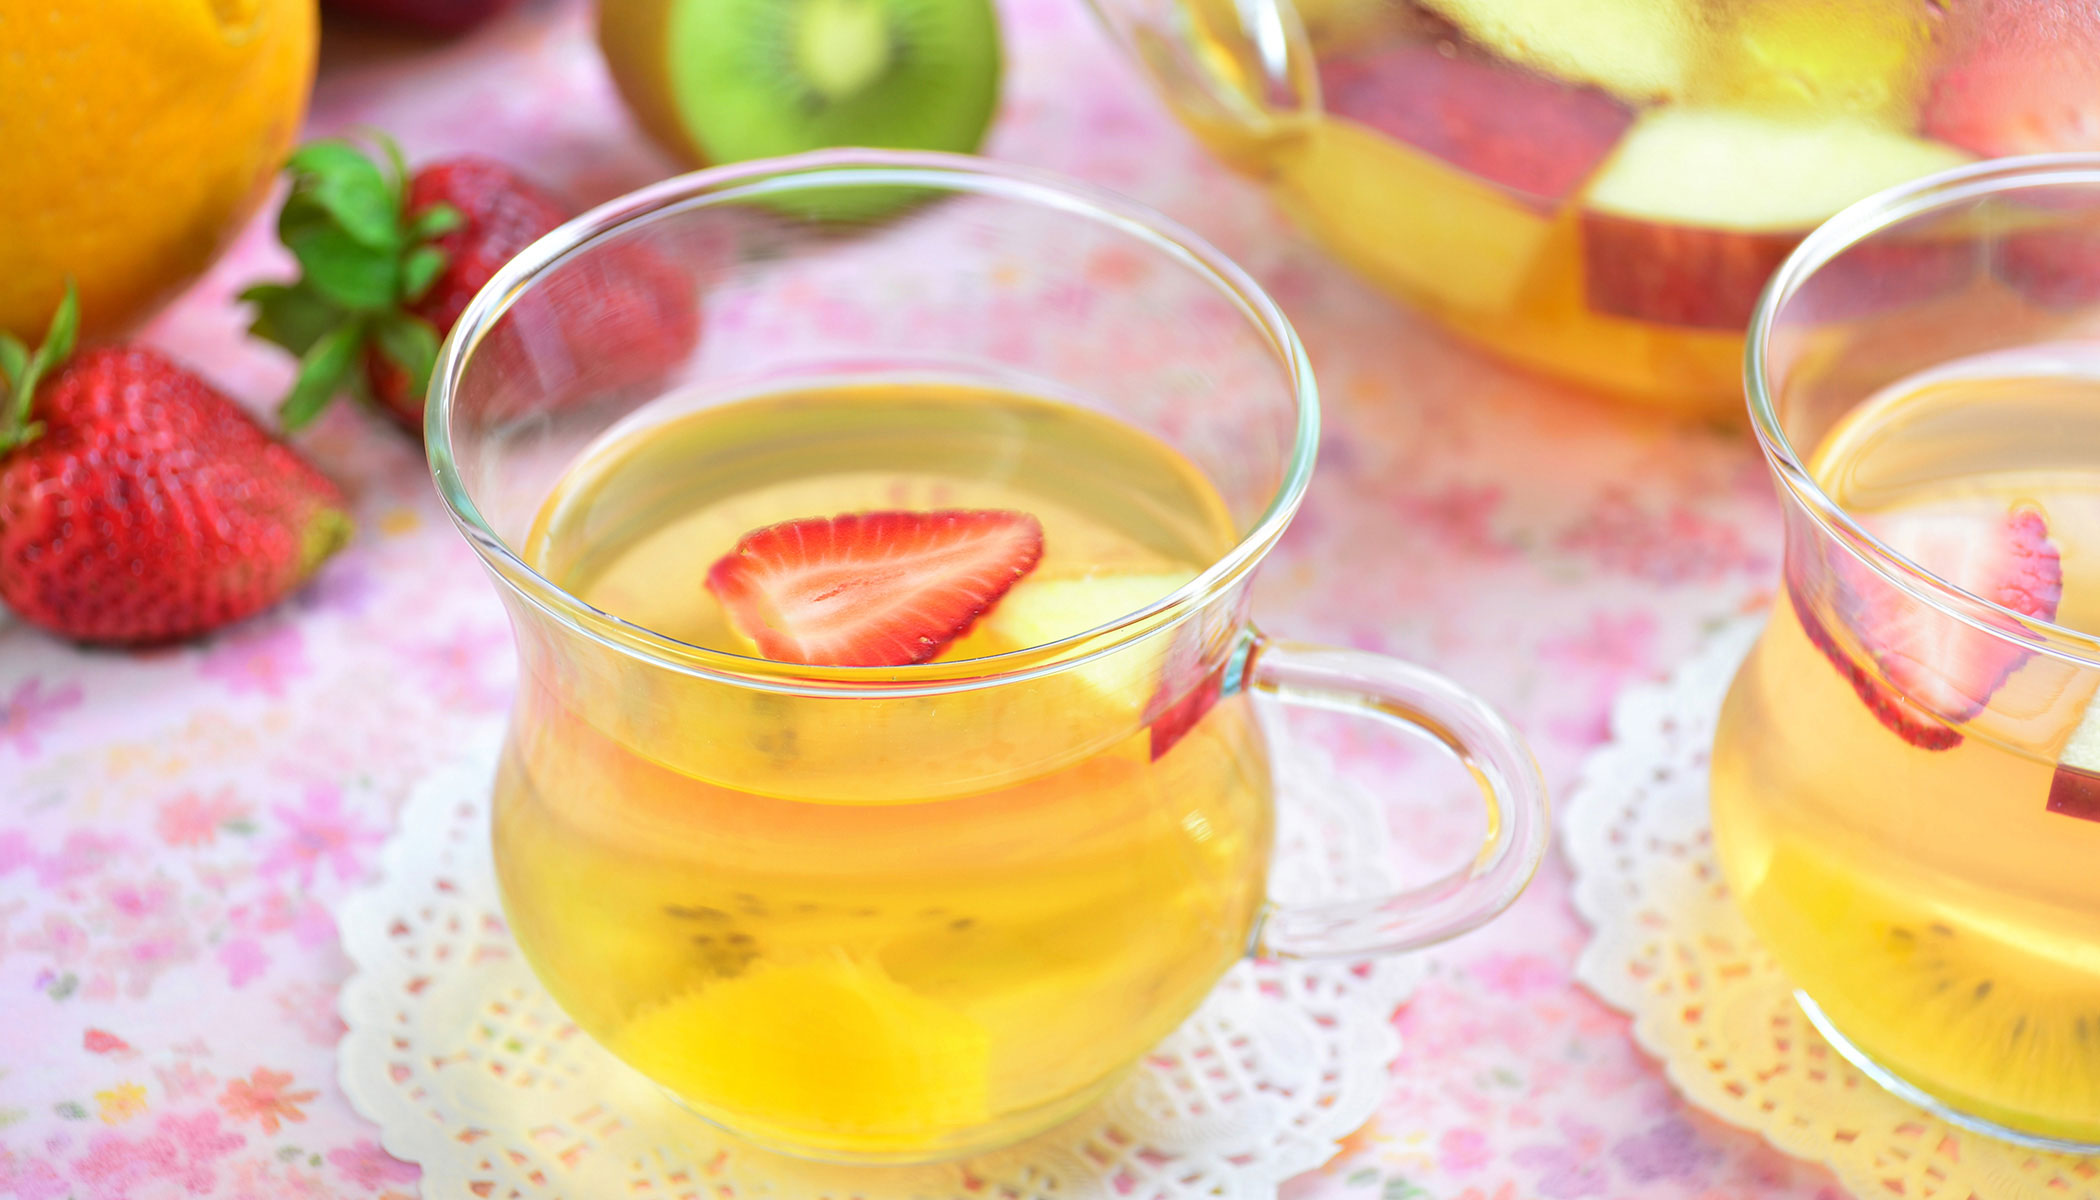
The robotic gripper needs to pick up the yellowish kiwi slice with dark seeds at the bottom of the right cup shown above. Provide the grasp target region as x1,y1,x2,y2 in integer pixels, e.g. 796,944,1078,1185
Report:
1749,847,2100,1143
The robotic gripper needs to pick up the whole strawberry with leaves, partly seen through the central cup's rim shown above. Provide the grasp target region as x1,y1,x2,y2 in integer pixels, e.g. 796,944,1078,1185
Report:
244,141,697,433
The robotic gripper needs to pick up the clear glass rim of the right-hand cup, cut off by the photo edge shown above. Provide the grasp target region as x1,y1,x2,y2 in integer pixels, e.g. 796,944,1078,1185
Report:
1743,153,2100,666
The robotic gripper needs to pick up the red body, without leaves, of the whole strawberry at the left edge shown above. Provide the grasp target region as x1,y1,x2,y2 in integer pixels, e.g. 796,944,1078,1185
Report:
0,349,351,645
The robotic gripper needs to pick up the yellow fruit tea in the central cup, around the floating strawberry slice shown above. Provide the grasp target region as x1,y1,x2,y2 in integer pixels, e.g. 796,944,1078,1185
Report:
496,382,1271,1160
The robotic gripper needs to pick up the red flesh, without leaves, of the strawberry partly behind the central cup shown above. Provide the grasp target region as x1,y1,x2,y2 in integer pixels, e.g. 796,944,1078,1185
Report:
380,156,699,435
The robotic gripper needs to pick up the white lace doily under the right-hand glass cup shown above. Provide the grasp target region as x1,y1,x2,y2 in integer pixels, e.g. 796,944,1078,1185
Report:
1562,618,2100,1200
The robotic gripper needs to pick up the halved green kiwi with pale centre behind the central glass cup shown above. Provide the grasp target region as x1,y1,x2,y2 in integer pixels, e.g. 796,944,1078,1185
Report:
599,0,1000,216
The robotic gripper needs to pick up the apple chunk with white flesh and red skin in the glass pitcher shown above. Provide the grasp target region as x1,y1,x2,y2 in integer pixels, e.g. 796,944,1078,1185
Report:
1583,109,1968,328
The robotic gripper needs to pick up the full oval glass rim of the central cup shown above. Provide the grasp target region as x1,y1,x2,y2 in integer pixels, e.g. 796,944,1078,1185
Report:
424,147,1319,696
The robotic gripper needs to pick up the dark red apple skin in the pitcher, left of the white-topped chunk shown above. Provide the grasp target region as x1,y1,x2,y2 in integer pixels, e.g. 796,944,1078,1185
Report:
1319,42,1634,210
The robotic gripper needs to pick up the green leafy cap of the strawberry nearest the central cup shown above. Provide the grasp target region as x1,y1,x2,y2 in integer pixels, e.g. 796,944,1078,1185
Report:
242,135,462,429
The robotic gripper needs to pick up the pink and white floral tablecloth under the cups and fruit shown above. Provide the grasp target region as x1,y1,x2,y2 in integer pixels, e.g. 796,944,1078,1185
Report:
0,0,1835,1200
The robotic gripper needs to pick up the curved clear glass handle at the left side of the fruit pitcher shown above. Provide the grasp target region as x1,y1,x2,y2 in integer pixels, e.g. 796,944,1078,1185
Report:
1092,0,1321,141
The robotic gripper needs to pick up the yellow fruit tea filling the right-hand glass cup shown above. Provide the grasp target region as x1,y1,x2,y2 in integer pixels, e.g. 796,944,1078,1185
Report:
1712,347,2100,1143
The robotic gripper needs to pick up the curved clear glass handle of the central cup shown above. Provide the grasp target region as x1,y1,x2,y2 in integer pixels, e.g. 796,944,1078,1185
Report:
1241,639,1550,958
